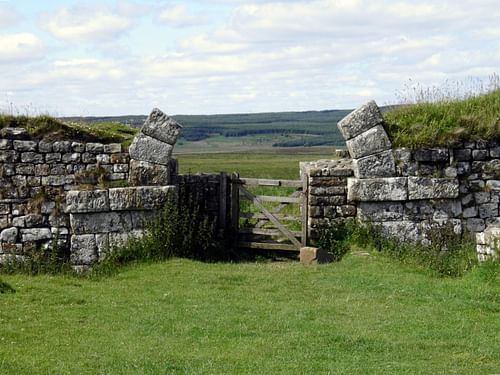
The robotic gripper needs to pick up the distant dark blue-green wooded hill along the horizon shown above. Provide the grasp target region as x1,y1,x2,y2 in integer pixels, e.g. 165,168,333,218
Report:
62,110,350,147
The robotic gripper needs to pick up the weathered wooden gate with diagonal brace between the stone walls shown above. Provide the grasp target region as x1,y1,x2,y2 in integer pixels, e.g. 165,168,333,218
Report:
231,173,307,251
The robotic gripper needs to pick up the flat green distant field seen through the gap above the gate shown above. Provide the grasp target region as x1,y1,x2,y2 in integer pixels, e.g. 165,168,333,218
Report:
177,147,335,179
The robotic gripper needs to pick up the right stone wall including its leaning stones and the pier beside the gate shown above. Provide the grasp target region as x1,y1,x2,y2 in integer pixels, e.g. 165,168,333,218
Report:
305,102,500,258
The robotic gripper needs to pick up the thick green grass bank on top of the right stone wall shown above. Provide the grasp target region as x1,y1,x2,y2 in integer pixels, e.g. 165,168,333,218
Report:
384,90,500,149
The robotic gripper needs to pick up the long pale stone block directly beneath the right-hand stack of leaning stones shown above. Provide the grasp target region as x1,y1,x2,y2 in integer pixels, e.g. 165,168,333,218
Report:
347,177,408,202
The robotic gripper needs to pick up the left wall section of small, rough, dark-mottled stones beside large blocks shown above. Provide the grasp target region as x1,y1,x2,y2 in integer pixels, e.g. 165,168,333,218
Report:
0,128,129,261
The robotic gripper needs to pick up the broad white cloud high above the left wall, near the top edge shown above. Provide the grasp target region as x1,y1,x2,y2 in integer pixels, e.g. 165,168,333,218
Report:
42,7,132,43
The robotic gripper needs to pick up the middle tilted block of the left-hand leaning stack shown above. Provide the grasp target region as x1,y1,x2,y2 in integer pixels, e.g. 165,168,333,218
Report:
129,133,174,165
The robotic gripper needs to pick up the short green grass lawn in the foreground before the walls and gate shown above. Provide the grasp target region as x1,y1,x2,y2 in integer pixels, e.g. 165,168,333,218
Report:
0,255,500,374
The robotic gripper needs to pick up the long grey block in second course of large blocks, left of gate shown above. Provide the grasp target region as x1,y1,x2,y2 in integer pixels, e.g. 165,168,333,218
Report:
70,211,132,234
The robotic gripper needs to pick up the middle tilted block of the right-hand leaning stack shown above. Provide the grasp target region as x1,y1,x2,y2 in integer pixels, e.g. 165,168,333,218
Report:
346,125,392,159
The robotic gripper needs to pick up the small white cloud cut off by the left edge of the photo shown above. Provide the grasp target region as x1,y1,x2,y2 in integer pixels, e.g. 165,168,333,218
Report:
0,33,43,63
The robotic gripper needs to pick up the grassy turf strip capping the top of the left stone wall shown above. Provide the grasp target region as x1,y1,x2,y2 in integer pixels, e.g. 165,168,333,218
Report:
0,114,138,146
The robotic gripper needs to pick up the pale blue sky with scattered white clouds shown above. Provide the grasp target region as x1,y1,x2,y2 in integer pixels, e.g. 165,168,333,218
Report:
0,0,500,116
